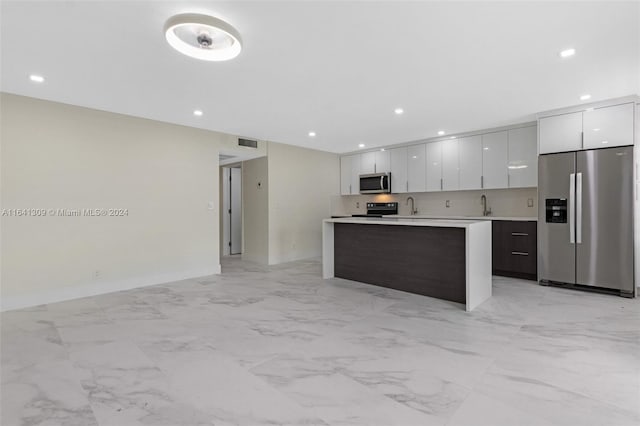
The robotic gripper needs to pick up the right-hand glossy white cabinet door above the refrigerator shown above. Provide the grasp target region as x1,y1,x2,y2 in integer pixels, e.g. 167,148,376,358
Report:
584,103,633,149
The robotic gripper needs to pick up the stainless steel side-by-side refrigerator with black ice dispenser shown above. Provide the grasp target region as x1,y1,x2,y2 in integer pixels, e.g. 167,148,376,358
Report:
538,146,635,297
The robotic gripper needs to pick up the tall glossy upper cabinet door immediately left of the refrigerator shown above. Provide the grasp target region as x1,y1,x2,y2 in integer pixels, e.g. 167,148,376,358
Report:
508,126,538,188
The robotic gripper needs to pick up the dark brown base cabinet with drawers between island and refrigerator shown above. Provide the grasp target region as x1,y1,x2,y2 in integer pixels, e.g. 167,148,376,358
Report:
491,220,538,280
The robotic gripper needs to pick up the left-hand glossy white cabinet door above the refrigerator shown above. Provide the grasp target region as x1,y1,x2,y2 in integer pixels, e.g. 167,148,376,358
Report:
538,112,582,154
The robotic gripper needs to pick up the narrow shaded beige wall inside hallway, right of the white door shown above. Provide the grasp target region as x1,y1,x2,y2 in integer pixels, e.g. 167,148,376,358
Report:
242,157,269,264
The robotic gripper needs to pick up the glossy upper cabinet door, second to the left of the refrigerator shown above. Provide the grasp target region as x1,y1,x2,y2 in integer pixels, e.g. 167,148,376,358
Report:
482,131,509,189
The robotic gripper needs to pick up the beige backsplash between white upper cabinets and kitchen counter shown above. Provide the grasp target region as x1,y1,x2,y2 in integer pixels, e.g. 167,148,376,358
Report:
331,188,538,217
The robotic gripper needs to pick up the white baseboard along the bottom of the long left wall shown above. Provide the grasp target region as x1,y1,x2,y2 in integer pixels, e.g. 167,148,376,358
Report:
0,264,222,312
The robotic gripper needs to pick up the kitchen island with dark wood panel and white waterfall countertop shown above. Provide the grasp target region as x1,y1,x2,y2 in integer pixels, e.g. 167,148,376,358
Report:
322,217,491,311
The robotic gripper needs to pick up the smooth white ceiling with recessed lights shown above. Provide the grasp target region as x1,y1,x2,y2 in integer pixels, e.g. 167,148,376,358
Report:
0,1,640,152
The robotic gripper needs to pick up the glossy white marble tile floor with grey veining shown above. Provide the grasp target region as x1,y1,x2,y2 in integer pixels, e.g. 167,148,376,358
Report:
0,258,640,426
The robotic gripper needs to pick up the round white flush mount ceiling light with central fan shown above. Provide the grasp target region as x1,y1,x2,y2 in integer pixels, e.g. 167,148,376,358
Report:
164,13,242,61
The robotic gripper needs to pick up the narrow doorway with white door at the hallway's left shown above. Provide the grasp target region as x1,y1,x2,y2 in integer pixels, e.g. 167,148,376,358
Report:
221,166,242,256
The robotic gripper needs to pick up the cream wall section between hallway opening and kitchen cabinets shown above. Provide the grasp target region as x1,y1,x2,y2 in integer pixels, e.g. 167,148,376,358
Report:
267,142,340,265
